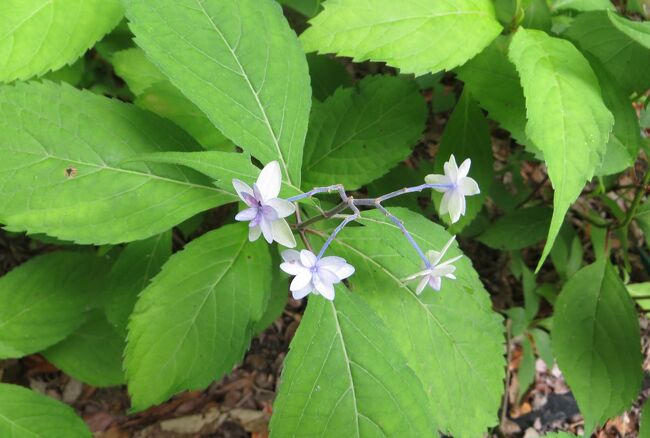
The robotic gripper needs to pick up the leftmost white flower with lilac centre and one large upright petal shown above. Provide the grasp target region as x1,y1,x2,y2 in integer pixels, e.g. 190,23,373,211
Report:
232,161,296,248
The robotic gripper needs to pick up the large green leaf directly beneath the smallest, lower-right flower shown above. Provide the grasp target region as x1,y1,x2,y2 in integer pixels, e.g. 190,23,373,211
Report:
332,208,505,437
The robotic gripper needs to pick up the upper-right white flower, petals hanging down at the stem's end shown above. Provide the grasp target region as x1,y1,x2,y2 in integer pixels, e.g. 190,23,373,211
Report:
424,155,481,223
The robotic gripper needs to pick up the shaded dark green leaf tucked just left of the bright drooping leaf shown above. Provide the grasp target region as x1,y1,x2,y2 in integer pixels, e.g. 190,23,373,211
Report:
456,36,529,149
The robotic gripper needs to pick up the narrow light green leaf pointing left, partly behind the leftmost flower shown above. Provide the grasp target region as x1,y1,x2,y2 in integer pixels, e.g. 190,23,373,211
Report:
126,151,302,197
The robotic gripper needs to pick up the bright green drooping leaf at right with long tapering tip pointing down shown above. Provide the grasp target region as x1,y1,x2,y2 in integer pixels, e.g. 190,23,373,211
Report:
509,28,614,269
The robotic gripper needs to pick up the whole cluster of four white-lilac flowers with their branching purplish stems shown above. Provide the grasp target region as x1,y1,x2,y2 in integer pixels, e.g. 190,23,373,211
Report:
232,155,479,300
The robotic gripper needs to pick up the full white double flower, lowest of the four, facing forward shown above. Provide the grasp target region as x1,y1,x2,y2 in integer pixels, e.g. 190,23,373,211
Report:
280,249,354,301
